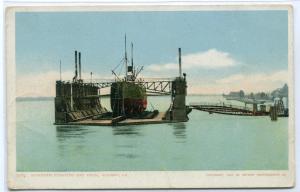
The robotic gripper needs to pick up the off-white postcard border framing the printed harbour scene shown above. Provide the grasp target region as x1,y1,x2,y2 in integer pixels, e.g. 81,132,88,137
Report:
5,3,295,189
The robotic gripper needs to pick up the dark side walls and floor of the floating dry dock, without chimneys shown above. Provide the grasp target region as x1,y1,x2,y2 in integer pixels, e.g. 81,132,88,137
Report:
55,77,191,126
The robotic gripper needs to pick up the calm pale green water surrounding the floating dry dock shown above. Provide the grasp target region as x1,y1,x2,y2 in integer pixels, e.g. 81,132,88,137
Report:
17,96,288,171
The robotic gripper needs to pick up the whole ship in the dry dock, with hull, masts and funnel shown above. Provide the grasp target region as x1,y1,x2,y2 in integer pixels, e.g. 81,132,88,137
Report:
110,36,147,117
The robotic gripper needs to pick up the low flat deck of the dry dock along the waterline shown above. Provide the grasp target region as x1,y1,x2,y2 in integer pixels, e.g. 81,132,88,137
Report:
56,112,174,126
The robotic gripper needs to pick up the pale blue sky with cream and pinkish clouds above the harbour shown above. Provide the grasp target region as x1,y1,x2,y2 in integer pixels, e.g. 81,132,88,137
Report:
16,10,288,97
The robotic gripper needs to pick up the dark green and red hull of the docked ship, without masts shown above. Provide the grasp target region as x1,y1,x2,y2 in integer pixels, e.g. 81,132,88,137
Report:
110,81,147,117
